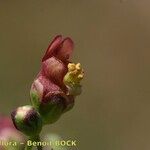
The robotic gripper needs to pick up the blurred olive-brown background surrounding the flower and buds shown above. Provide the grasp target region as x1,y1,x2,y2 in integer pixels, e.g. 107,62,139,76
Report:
0,0,150,150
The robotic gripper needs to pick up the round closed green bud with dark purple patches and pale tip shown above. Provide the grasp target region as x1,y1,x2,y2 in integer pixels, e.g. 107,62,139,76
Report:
11,105,42,136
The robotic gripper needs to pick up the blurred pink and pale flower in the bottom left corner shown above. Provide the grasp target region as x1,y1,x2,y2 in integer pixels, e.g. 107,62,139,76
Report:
0,115,25,150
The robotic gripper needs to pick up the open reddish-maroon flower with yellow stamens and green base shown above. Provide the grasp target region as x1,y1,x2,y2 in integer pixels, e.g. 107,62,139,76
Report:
30,35,83,124
